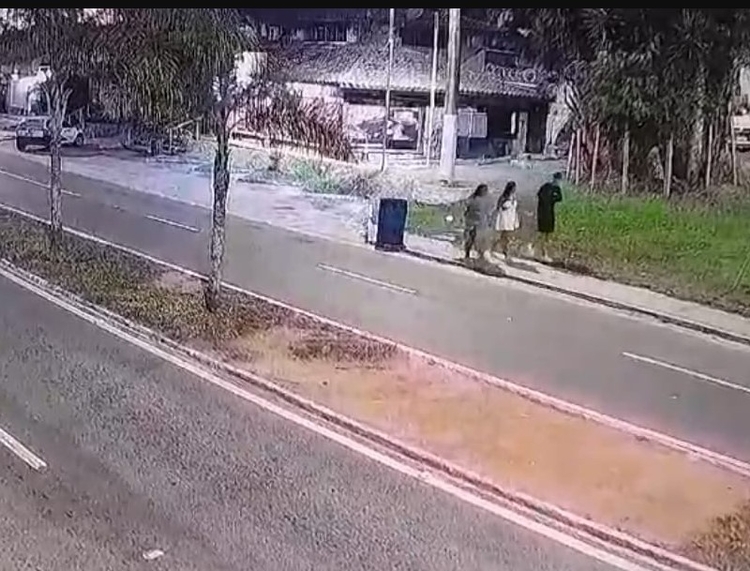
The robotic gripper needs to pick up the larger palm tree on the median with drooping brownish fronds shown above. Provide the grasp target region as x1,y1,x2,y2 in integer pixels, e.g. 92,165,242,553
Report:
98,8,351,311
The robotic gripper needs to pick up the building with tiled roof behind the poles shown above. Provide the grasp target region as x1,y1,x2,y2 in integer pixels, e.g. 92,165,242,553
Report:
253,9,555,160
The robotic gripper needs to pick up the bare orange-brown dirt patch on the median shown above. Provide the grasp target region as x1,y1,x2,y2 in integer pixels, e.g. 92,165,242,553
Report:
213,329,750,547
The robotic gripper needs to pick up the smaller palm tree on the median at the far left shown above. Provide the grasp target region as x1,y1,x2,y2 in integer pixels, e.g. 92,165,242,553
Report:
0,8,99,249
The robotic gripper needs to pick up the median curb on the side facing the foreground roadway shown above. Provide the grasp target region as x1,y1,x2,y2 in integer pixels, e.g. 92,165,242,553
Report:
0,259,715,571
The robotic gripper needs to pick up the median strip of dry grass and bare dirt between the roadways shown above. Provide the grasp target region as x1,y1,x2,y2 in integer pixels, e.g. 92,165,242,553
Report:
0,211,750,569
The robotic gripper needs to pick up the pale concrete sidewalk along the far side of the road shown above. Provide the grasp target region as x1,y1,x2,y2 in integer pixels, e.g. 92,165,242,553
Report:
5,141,750,345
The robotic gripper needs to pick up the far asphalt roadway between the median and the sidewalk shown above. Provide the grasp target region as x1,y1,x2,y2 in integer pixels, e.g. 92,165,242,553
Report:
0,149,750,460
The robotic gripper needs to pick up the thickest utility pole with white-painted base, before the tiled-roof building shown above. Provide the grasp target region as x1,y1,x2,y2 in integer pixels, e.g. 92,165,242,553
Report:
440,8,461,183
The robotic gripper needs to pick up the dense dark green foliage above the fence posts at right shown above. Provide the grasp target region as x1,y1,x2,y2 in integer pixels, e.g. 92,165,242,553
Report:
514,8,750,187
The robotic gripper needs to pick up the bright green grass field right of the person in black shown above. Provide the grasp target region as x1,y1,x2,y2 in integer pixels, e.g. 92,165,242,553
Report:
555,190,750,315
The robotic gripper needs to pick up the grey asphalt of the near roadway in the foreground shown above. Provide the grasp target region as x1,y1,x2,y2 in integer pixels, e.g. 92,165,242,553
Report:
0,272,636,571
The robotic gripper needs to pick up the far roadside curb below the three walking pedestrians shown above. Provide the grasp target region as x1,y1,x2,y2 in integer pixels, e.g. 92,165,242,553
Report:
403,249,750,345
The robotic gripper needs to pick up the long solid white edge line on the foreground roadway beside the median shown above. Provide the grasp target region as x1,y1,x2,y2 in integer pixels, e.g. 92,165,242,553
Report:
0,268,648,571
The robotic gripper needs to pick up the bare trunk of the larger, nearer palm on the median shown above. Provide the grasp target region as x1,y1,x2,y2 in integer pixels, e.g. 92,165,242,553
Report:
204,109,229,312
